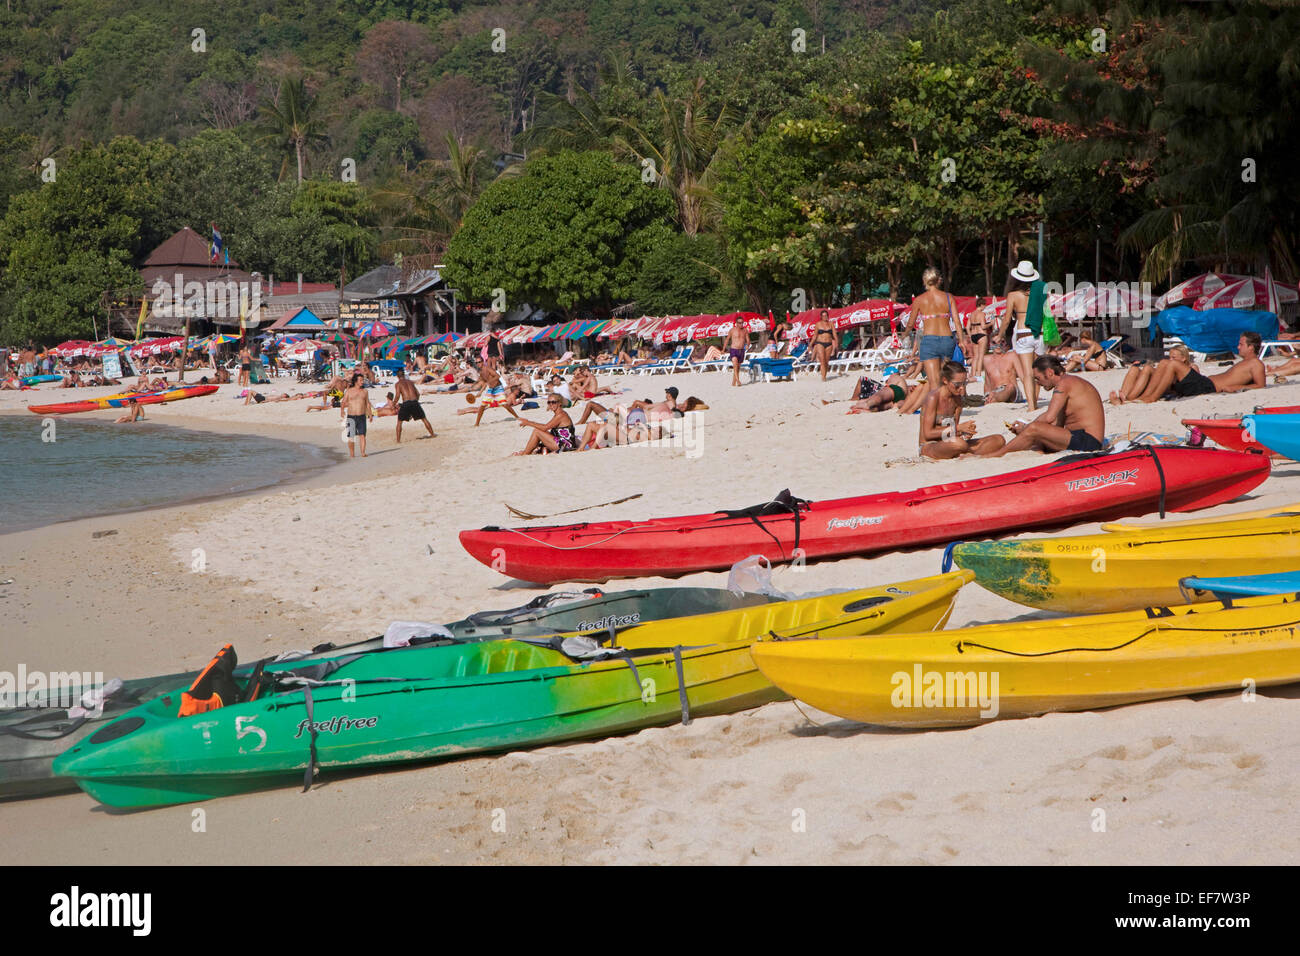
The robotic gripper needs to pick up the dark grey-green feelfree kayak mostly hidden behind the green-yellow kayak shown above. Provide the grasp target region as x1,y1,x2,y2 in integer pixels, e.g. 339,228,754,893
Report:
0,588,775,799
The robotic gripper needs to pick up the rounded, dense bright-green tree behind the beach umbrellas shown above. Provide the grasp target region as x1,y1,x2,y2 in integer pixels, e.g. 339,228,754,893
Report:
445,152,672,312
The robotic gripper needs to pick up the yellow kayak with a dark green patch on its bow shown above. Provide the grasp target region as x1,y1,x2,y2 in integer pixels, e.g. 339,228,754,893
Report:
952,511,1300,614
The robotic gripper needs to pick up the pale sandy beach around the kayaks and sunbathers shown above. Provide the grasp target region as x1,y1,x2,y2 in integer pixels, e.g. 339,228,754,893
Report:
0,372,1300,865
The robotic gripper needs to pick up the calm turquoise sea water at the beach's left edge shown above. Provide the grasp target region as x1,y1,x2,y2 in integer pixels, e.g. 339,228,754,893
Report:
0,415,335,535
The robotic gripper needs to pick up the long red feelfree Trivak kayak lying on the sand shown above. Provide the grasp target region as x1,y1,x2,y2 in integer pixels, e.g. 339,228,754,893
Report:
460,446,1269,584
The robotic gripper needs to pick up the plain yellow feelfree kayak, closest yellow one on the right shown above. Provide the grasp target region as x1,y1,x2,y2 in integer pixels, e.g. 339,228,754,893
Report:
753,594,1300,727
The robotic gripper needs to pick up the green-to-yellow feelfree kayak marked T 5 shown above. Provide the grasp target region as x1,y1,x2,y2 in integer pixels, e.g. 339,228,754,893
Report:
55,572,970,806
